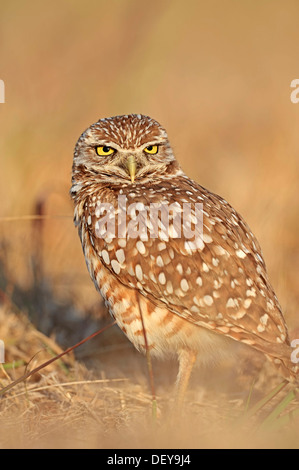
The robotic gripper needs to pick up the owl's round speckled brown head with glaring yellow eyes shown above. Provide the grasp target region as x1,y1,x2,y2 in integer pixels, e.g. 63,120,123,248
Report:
73,114,182,189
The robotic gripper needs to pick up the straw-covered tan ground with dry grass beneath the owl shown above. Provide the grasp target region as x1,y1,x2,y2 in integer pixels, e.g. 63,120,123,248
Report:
0,305,299,449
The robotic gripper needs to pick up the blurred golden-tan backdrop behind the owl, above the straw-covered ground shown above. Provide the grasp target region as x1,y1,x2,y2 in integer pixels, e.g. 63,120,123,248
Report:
0,0,299,390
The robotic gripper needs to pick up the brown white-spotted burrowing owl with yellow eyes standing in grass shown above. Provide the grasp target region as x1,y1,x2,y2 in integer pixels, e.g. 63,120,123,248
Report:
71,114,296,400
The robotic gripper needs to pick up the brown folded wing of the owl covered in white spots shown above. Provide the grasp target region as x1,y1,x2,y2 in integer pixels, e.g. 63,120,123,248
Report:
86,177,288,357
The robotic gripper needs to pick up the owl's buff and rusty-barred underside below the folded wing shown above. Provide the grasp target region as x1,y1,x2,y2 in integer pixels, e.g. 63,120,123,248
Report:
79,220,235,363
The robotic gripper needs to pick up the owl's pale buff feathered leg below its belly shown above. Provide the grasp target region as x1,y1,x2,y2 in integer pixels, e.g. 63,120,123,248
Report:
175,349,197,411
